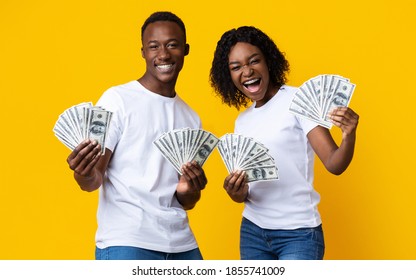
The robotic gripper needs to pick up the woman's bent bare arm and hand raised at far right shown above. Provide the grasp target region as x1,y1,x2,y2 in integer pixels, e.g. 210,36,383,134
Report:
308,107,359,175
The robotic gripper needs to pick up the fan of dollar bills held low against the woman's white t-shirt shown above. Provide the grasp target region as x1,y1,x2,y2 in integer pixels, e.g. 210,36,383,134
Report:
218,133,279,182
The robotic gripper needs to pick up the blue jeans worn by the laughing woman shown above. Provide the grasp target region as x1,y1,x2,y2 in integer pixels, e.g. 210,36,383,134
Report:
240,218,325,260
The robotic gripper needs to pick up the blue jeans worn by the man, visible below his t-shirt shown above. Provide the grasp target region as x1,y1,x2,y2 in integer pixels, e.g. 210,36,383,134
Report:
95,246,202,260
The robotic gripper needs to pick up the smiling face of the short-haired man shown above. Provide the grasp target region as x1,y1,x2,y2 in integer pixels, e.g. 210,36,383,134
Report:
142,21,189,87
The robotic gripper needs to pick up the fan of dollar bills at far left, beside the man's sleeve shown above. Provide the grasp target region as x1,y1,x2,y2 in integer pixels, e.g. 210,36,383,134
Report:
53,102,112,154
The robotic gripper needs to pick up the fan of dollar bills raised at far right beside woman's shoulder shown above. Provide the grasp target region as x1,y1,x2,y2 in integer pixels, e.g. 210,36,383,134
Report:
289,74,355,128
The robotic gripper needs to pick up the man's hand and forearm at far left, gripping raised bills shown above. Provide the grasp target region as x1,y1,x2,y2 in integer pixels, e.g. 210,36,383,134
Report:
67,140,112,192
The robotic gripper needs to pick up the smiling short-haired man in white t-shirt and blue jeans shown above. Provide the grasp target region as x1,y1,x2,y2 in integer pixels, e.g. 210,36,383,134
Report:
67,12,207,260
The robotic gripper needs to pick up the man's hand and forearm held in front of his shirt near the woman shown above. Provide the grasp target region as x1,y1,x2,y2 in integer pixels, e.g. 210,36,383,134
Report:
176,161,208,210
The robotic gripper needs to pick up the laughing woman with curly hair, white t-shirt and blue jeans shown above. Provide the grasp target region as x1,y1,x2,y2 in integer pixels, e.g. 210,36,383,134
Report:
210,26,359,260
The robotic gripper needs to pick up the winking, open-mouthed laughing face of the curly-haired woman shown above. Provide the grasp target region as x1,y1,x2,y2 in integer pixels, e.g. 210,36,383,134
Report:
228,42,275,107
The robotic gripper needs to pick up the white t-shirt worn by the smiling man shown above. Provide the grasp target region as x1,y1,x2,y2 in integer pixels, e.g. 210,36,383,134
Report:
96,81,201,253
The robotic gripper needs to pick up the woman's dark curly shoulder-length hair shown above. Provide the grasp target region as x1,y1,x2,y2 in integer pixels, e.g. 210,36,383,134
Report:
209,26,289,110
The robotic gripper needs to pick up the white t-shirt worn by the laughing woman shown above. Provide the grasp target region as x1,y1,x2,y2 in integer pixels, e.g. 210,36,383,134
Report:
235,85,321,229
